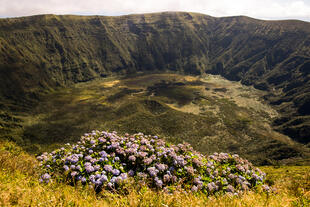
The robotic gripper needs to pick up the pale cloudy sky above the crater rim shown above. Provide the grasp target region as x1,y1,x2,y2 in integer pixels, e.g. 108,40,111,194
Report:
0,0,310,21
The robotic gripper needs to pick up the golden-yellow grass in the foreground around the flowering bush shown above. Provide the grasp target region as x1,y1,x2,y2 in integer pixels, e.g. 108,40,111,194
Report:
0,141,310,206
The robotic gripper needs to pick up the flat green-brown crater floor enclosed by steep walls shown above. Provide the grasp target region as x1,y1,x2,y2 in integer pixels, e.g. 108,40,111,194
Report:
0,73,309,164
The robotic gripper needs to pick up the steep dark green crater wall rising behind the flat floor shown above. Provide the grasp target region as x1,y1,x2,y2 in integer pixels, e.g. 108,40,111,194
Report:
0,12,310,144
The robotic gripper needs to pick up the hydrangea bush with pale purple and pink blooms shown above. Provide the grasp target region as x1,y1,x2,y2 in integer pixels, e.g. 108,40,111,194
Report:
37,131,269,194
